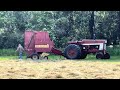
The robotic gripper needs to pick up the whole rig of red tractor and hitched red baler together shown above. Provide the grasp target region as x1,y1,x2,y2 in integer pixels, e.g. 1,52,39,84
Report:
24,31,110,59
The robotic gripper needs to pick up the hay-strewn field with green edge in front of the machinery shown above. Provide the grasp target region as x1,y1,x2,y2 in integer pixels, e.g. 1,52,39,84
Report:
0,56,120,79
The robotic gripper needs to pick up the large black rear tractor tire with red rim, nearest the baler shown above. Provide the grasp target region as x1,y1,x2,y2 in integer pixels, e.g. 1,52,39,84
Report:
64,44,81,59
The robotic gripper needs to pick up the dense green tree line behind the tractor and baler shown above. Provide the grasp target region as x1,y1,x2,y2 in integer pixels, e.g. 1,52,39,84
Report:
0,11,120,49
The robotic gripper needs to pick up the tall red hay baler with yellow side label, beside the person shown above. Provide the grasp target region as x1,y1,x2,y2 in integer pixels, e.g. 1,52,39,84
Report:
24,30,62,59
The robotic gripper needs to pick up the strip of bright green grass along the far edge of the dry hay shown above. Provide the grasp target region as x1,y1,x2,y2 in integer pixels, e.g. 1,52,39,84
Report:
0,55,120,62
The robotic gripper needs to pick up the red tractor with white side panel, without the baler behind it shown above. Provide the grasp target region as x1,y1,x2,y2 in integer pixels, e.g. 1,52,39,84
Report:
64,39,110,59
